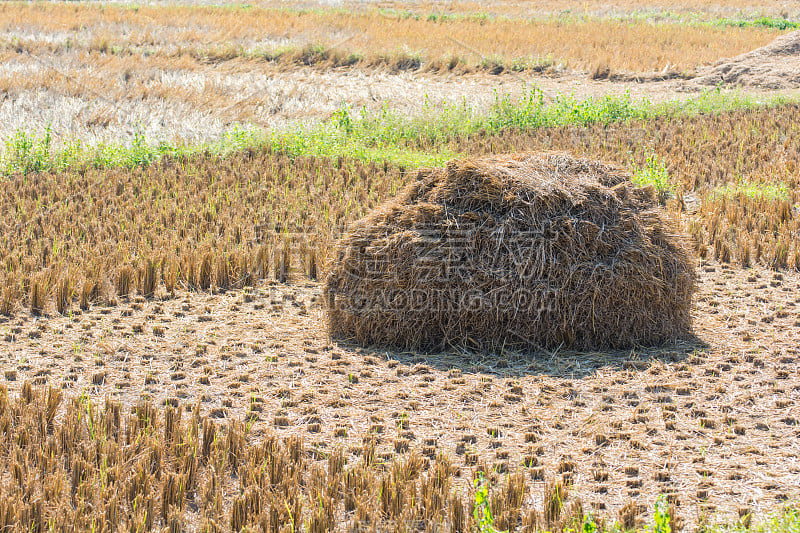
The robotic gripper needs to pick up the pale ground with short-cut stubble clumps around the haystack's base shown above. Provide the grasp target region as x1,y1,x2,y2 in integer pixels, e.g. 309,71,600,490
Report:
0,264,800,522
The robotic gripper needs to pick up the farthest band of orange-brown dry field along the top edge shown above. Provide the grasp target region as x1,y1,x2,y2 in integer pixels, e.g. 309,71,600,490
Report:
0,4,780,72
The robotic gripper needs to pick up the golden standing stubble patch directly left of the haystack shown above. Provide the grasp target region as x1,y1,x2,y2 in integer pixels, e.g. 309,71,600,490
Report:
0,151,406,314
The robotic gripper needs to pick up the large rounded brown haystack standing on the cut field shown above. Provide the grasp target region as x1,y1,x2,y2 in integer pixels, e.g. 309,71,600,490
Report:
325,152,695,351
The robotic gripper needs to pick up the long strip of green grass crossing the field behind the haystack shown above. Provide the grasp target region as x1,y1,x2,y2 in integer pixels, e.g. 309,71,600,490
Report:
0,87,800,177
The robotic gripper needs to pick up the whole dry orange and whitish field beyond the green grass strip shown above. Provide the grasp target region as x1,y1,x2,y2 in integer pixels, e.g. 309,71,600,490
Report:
0,4,781,145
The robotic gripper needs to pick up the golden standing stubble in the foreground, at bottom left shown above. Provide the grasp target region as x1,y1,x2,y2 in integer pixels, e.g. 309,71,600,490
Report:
0,383,612,533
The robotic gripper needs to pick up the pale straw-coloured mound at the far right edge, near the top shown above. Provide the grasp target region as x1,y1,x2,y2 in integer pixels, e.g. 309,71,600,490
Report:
697,31,800,89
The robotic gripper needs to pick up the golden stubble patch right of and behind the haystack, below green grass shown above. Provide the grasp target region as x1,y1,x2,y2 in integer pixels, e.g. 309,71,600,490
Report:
448,104,800,269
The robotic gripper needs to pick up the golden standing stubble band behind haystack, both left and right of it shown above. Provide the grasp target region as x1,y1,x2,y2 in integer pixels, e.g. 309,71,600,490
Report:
0,104,800,314
